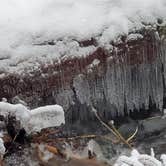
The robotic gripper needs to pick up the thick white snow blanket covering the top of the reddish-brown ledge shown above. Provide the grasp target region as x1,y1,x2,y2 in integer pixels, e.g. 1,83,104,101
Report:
0,0,166,72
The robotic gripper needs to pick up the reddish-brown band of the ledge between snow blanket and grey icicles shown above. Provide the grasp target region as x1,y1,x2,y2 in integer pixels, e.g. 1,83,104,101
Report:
0,29,163,122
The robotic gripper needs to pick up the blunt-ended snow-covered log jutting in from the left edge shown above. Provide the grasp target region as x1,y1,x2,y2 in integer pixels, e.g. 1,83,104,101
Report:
0,102,65,133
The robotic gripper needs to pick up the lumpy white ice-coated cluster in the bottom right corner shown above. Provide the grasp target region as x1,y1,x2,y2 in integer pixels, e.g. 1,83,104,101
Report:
114,149,166,166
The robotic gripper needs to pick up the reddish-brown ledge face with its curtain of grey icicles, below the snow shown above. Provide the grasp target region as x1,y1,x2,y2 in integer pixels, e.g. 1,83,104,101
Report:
0,31,166,122
